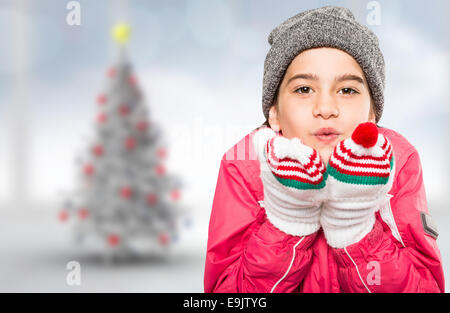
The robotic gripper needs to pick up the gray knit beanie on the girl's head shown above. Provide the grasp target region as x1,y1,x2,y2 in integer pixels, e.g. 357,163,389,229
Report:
262,6,385,123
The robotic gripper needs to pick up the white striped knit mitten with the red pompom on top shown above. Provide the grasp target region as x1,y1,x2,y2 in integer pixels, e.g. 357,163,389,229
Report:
320,122,395,248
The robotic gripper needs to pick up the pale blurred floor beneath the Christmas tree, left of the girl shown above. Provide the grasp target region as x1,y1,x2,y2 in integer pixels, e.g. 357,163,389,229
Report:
0,201,208,293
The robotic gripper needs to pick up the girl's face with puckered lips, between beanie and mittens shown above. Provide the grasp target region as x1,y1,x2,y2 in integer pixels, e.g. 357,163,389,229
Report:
269,47,375,163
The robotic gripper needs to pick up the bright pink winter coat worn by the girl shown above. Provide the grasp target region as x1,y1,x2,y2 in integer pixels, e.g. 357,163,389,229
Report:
204,128,444,293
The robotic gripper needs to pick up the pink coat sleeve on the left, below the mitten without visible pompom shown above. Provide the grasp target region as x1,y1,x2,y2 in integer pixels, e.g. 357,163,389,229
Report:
204,157,316,293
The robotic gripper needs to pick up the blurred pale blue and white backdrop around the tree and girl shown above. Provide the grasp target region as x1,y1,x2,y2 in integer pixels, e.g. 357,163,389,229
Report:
0,0,450,292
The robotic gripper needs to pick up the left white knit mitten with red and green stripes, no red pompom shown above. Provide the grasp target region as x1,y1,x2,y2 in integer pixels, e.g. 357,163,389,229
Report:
253,127,326,236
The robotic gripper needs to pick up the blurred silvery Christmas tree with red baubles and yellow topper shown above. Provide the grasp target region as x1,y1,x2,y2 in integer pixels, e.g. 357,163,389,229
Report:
59,24,185,257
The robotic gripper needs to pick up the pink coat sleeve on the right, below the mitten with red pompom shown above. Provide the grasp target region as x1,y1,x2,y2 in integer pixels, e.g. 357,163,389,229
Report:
333,149,444,292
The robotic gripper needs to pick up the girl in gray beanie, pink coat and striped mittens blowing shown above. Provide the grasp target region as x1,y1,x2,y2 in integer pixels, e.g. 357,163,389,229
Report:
204,6,444,292
